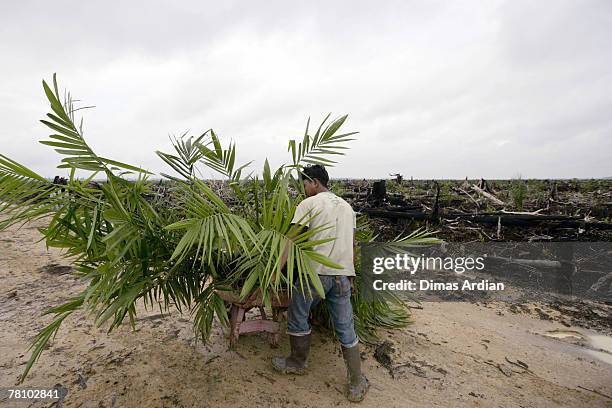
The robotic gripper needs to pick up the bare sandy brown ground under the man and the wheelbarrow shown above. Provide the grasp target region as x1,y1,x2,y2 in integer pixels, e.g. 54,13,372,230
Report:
0,224,612,408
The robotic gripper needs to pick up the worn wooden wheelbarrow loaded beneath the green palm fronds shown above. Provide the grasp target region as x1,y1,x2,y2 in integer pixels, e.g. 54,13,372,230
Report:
216,289,289,348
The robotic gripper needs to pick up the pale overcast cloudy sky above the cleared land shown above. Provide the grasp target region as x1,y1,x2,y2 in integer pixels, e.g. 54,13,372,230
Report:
0,0,612,178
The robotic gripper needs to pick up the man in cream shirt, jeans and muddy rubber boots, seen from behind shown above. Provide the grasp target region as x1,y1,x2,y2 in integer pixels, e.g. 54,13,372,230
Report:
272,165,369,402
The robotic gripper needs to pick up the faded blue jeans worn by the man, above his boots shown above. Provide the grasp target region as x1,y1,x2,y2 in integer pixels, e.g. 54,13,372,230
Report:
287,275,359,347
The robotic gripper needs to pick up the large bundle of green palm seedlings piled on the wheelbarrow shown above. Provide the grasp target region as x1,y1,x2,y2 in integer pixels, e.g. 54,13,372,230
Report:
0,75,435,381
